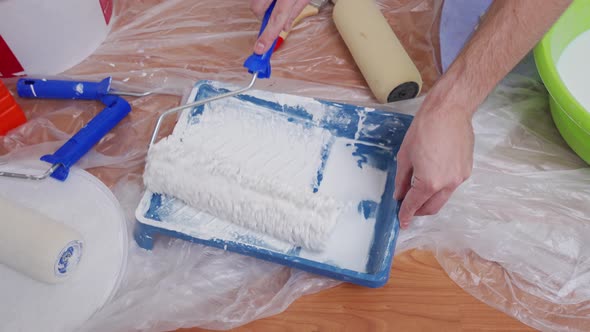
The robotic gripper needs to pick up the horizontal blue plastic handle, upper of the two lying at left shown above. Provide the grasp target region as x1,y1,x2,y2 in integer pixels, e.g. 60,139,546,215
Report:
16,77,111,100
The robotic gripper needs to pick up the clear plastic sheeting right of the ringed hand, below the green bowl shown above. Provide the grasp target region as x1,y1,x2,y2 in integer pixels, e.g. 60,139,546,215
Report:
398,62,590,331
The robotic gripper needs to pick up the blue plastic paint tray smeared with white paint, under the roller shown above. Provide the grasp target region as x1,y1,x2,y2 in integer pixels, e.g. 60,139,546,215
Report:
134,81,412,287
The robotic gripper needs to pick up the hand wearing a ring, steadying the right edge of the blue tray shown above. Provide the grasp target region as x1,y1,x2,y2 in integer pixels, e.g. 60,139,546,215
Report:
395,83,474,228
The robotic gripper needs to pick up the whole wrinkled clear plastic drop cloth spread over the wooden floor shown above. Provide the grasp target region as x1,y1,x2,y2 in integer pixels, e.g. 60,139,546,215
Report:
0,0,590,331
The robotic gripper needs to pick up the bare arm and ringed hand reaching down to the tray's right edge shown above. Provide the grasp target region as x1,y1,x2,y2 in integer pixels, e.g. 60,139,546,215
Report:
395,0,571,228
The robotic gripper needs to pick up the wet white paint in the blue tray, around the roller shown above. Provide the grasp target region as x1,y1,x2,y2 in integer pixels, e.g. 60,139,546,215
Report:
136,81,398,272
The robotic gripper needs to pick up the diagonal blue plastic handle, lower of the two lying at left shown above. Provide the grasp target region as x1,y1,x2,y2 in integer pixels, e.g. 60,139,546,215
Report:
41,96,131,181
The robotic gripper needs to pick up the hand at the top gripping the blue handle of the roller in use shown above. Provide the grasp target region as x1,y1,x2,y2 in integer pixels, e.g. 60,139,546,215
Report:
250,0,310,54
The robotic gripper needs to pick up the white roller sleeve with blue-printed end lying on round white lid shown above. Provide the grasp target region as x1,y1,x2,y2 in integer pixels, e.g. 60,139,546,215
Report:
0,197,83,283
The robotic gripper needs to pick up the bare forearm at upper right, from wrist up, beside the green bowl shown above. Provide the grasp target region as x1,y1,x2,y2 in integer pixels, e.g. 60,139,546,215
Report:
433,0,571,112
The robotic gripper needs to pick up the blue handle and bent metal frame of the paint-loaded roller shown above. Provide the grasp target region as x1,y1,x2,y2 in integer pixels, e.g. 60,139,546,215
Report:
149,0,278,147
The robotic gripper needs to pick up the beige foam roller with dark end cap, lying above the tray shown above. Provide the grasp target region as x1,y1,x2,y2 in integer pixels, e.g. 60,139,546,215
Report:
332,0,422,103
